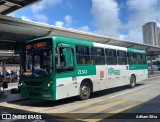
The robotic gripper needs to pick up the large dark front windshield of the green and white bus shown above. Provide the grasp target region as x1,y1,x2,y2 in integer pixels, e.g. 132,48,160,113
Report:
21,48,52,78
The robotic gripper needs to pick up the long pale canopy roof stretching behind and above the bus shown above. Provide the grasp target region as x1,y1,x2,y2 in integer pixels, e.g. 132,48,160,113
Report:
0,15,160,55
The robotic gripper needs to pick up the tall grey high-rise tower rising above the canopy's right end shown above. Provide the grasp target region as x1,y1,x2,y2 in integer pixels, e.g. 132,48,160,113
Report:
142,22,160,47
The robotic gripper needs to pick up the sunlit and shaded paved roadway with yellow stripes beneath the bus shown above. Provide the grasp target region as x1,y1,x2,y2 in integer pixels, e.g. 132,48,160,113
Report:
0,76,160,122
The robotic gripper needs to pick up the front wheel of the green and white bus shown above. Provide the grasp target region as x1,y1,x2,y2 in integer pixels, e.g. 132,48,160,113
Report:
79,82,91,100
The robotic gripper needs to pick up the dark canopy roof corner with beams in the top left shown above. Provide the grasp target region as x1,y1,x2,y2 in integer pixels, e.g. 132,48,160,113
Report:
0,0,40,15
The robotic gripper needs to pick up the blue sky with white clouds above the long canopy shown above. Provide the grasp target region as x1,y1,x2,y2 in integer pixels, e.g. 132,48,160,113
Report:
12,0,160,43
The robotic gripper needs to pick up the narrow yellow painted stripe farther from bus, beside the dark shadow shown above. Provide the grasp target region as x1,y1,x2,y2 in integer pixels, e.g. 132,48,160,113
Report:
83,103,141,122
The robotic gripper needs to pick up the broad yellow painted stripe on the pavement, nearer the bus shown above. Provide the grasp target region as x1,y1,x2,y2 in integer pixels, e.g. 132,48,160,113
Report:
60,100,126,119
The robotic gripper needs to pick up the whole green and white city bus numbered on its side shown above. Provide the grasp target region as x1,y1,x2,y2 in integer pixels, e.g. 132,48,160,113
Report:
20,36,148,100
